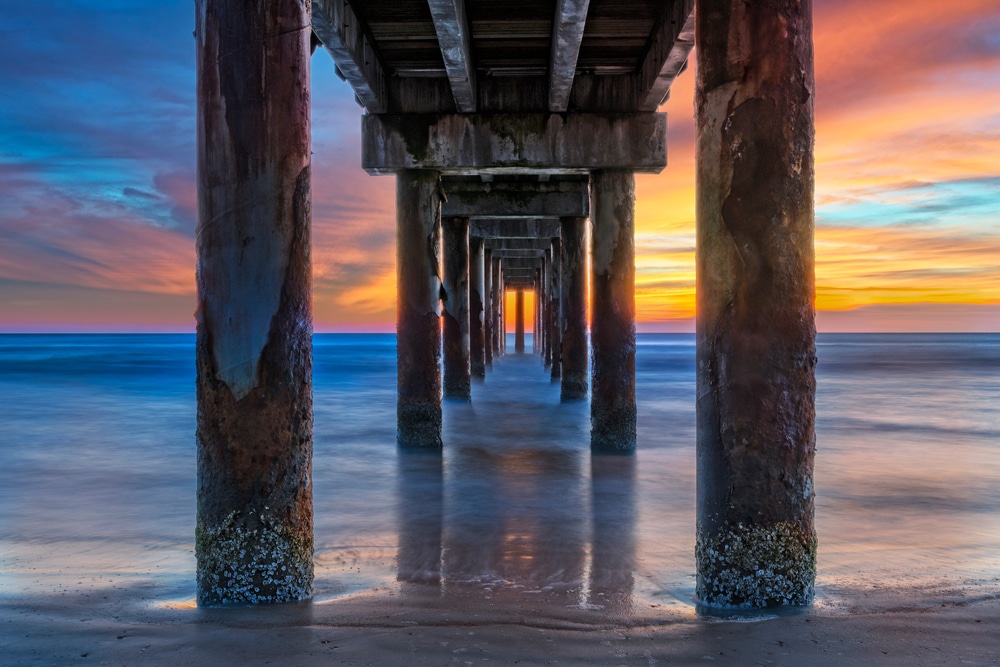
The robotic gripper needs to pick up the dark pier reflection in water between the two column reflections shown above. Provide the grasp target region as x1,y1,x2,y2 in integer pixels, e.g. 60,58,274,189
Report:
444,447,586,605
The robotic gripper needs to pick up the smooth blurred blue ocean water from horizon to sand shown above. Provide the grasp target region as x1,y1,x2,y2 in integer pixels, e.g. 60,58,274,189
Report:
0,334,1000,616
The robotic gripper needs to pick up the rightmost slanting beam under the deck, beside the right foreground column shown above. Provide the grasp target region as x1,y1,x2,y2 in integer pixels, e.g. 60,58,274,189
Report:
638,0,694,111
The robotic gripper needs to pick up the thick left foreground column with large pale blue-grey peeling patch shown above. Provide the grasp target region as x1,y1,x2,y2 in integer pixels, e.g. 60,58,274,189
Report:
195,0,313,606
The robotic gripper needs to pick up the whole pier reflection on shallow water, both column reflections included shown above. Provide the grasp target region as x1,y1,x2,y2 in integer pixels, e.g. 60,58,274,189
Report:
397,446,635,615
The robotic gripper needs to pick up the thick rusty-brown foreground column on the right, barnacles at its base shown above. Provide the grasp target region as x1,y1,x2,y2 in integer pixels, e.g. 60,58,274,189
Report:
696,0,816,607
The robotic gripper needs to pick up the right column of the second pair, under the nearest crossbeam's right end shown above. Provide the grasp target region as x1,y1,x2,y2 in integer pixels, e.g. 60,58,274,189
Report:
590,170,635,450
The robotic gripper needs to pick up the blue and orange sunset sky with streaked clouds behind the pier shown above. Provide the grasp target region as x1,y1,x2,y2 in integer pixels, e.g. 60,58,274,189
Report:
0,0,1000,332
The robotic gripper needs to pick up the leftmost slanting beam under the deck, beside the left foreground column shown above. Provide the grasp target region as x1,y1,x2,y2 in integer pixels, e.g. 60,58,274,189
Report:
312,0,389,113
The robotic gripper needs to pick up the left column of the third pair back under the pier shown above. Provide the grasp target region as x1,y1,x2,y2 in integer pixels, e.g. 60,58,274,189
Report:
441,218,472,401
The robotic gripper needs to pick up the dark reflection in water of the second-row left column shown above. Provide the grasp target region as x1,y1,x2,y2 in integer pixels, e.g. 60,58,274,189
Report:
396,449,444,587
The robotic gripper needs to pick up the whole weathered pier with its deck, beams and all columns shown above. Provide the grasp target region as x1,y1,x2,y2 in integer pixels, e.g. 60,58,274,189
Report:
196,0,816,607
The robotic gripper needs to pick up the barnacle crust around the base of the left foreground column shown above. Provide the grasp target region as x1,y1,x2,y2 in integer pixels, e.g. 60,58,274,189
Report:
195,512,313,607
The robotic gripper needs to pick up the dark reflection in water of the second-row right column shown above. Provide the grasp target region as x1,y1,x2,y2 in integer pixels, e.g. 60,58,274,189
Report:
587,454,636,613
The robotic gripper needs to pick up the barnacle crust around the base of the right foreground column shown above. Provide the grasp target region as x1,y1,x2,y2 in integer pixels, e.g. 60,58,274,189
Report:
695,522,816,609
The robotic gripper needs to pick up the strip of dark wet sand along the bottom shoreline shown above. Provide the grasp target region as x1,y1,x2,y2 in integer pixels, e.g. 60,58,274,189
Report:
0,590,1000,667
